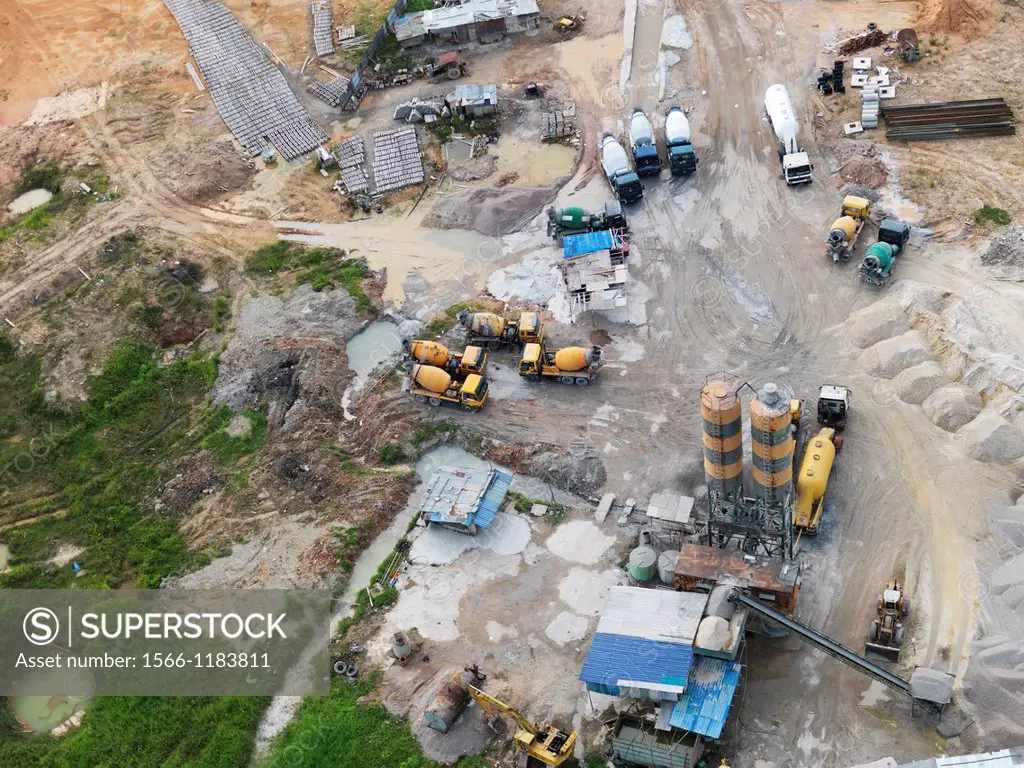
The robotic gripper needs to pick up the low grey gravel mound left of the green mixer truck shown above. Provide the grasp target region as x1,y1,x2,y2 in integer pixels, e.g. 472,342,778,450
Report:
423,186,555,237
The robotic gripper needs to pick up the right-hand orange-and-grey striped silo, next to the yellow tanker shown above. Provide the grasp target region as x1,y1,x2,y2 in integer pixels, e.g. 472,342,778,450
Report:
751,384,795,505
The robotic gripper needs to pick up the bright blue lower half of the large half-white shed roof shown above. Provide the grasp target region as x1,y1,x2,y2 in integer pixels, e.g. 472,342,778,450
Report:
580,634,693,698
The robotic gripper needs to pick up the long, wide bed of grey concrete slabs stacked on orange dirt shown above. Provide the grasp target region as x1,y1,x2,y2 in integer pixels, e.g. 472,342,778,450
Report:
164,0,327,160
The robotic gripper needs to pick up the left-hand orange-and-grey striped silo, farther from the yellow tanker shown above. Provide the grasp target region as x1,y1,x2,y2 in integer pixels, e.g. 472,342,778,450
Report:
700,377,743,498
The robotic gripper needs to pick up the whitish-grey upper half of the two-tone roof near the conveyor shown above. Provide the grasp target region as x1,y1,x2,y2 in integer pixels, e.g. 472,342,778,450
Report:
597,587,708,647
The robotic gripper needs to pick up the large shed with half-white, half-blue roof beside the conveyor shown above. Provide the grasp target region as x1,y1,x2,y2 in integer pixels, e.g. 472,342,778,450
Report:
580,587,708,702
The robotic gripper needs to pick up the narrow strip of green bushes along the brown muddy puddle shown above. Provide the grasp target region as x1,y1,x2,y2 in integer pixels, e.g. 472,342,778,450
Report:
246,241,376,314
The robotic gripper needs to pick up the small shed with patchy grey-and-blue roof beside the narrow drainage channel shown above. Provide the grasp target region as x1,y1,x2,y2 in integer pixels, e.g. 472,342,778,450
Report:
419,467,512,534
